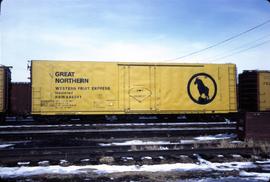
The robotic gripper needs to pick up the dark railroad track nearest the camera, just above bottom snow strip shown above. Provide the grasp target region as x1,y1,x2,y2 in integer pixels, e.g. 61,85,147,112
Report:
0,144,257,166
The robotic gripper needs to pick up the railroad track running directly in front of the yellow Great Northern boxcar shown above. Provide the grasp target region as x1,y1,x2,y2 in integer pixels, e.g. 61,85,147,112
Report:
0,122,237,140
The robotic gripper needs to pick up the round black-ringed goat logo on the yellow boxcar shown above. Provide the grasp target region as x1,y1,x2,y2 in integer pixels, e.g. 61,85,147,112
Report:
187,73,217,105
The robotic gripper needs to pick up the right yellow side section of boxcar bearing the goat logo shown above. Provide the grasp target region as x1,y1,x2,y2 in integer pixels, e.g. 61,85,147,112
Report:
157,65,236,113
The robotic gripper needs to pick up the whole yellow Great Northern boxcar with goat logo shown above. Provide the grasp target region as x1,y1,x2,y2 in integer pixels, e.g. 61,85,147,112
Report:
32,60,237,115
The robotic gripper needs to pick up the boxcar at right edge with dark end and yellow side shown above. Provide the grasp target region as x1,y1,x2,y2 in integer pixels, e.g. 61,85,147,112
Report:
239,70,270,112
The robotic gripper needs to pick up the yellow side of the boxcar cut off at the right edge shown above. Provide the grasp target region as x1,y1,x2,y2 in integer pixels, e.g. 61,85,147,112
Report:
259,72,270,111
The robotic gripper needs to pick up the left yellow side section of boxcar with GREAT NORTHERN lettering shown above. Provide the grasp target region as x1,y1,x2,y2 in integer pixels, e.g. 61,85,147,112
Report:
32,61,119,114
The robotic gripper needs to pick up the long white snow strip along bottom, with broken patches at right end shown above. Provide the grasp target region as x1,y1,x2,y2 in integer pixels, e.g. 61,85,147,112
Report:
0,159,270,179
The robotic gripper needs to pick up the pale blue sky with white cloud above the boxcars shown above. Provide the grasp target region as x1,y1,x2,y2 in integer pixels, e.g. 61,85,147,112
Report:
0,0,270,81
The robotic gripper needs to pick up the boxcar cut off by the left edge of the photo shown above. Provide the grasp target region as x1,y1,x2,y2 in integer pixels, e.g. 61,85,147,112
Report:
0,66,11,121
